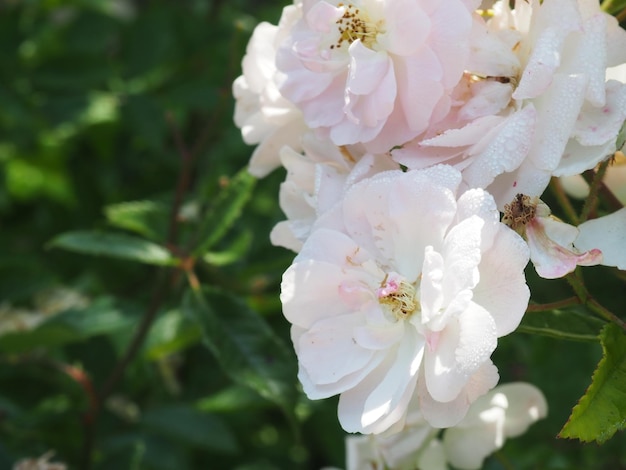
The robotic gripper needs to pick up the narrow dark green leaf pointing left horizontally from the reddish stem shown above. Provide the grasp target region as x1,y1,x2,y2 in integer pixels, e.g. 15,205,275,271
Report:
48,231,177,266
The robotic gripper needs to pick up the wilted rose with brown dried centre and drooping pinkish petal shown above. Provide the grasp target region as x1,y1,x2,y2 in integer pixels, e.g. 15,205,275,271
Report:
502,194,603,279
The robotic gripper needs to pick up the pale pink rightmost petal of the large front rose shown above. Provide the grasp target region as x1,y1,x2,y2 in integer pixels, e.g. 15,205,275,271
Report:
473,226,530,337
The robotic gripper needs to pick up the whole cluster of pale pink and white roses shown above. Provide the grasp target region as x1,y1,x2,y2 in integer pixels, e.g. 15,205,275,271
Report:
233,0,626,468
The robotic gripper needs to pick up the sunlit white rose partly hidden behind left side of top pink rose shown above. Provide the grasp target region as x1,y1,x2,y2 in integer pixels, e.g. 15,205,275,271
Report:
233,5,307,178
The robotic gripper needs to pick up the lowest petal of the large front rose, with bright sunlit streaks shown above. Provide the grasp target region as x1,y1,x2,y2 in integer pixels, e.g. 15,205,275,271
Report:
338,328,424,433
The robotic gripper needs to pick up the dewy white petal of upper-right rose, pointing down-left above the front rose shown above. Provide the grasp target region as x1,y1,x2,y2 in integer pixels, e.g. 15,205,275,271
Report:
463,105,536,188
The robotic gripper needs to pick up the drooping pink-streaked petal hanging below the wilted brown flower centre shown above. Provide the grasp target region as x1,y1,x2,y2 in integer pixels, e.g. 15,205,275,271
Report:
526,217,602,279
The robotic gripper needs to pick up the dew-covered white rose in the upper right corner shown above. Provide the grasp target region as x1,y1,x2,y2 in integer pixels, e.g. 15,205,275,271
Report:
393,0,626,209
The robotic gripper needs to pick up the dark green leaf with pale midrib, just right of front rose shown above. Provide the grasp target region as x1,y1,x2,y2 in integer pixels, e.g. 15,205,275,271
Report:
516,308,605,343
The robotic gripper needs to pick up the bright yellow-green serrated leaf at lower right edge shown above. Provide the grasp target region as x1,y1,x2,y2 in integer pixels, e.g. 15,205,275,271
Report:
559,323,626,444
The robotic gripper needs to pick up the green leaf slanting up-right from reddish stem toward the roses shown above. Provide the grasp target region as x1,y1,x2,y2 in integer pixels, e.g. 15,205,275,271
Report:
194,168,256,256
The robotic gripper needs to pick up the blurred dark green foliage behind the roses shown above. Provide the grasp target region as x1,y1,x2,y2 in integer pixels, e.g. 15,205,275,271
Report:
0,0,626,470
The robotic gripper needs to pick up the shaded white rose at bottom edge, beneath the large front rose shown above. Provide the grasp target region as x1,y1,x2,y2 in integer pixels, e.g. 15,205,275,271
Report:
346,382,548,470
